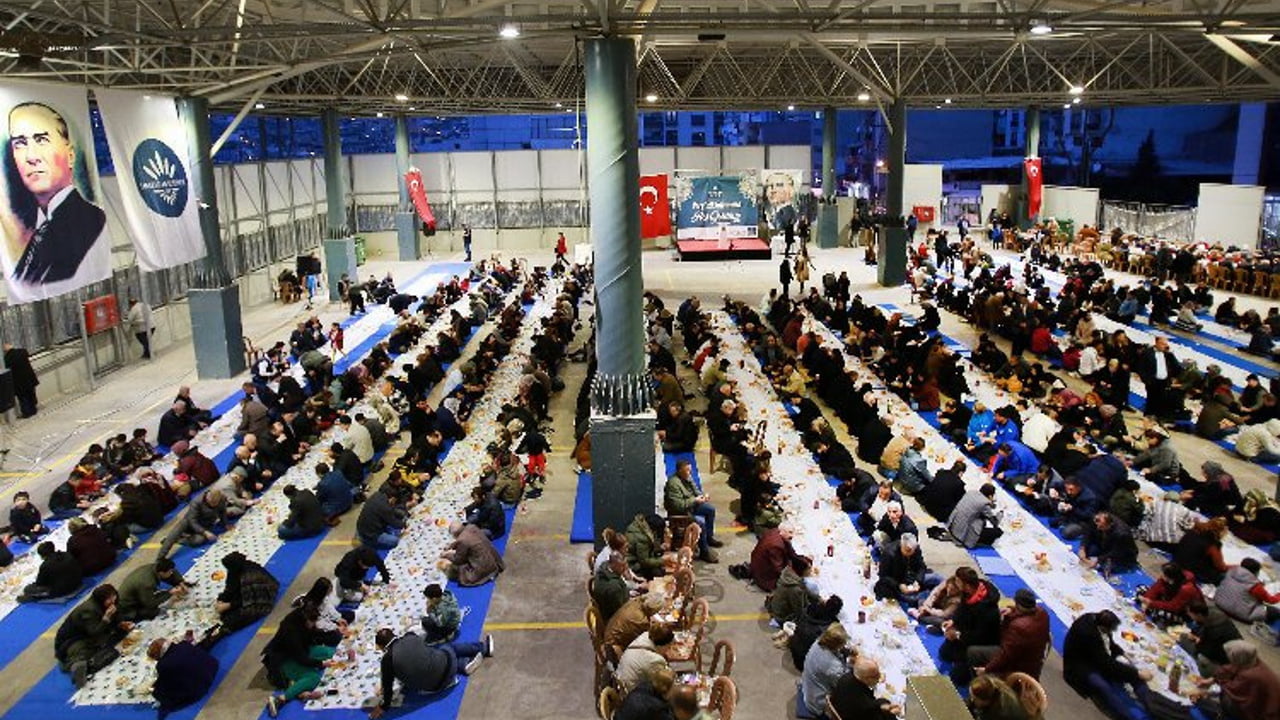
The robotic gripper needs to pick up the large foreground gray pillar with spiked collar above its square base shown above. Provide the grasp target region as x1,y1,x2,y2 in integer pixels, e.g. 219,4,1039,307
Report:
585,37,655,543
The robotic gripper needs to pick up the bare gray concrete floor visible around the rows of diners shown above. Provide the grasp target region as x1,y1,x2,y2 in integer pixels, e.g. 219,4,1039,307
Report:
0,242,1280,720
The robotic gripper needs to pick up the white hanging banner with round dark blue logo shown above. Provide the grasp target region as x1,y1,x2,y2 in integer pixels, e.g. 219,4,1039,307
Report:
93,88,205,272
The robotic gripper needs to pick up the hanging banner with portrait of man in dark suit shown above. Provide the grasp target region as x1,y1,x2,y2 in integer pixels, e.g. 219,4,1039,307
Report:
0,82,111,305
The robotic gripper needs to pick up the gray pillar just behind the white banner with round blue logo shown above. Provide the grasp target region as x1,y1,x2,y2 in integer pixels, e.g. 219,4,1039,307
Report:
178,97,247,379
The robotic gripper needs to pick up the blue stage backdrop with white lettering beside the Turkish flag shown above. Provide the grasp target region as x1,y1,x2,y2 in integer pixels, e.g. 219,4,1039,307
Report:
676,170,760,241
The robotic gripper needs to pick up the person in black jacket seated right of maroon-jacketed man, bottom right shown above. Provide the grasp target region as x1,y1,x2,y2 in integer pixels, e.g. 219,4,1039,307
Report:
1062,610,1152,717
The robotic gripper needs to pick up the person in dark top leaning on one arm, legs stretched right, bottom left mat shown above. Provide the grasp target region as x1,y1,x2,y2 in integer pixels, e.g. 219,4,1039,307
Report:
369,628,493,720
